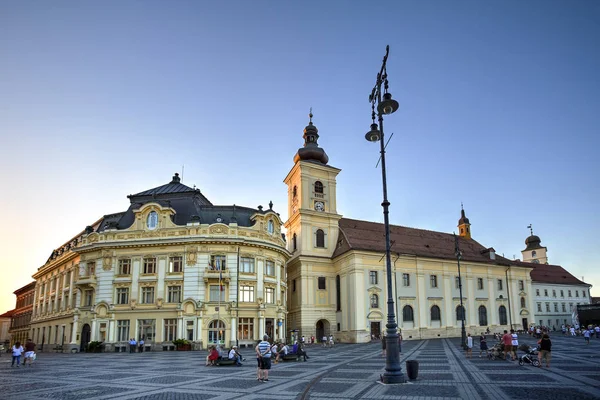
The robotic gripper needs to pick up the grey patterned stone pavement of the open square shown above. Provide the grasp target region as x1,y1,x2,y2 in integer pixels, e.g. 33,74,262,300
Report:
0,334,600,400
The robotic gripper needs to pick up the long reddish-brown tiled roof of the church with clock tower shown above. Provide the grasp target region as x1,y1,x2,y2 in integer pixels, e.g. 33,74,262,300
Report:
333,218,511,266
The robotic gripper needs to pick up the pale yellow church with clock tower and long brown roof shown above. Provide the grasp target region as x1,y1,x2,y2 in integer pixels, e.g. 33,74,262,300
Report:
284,115,534,342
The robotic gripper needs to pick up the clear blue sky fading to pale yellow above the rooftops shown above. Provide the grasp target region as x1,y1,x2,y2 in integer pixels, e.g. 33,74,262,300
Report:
0,0,600,313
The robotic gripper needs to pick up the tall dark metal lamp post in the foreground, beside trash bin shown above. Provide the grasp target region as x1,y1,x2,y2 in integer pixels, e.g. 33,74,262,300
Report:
365,46,405,384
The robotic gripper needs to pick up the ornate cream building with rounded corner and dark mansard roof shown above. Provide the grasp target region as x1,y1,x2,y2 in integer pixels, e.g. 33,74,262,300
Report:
34,174,289,351
